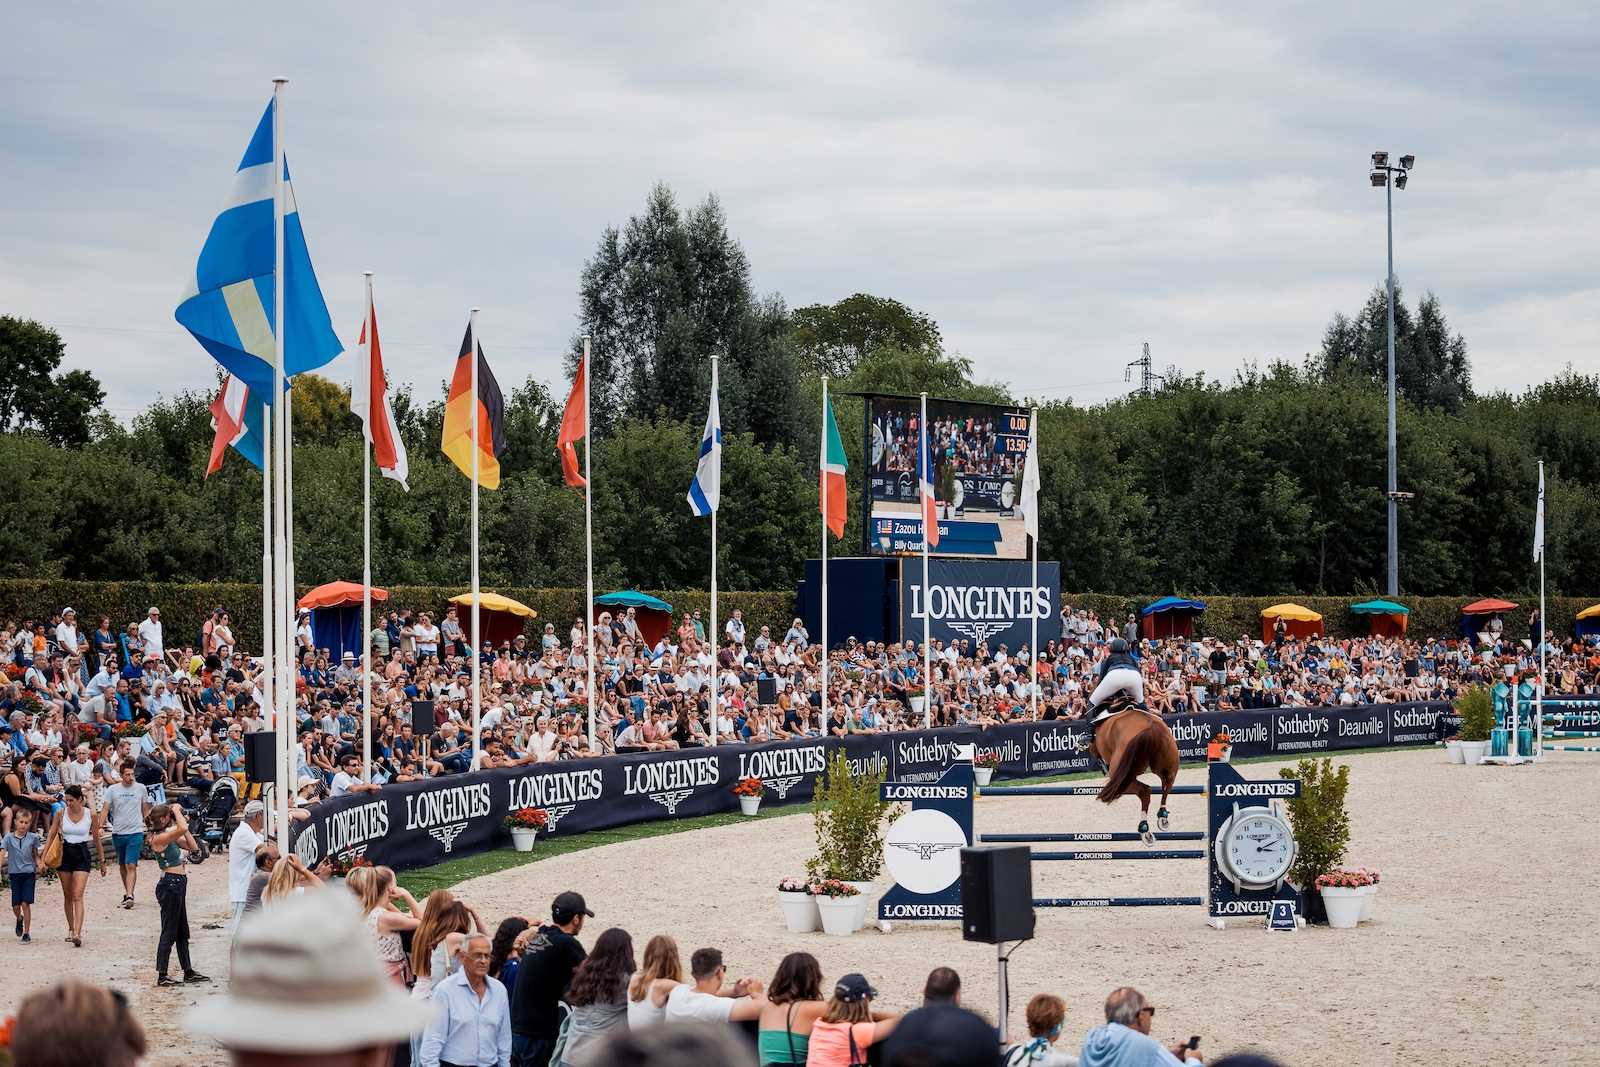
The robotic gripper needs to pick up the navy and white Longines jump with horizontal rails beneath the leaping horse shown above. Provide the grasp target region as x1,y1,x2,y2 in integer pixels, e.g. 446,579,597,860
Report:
878,747,1301,929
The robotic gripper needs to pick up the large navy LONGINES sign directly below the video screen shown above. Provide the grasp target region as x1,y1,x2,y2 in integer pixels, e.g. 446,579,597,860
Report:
901,558,1061,654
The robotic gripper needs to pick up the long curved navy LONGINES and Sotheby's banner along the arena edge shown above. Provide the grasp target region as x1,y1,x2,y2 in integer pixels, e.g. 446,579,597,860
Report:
294,704,1450,870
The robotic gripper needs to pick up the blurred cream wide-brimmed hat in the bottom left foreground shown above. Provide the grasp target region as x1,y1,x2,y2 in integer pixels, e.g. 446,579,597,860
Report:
186,889,430,1053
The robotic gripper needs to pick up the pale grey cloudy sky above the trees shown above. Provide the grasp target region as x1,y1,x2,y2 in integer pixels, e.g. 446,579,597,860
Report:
0,2,1600,419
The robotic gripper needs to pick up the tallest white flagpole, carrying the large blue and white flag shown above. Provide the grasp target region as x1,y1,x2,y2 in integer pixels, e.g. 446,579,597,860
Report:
262,78,294,856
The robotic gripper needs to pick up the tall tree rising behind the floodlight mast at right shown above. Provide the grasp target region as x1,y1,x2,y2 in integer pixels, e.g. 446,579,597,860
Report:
1322,282,1472,414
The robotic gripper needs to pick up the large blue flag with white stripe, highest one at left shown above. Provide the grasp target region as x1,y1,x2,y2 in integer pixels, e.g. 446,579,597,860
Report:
176,104,344,400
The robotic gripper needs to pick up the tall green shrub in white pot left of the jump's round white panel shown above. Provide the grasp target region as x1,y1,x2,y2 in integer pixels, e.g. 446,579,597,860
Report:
805,749,898,929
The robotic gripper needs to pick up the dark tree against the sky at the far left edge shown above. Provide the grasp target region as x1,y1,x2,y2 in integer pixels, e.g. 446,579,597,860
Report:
0,315,106,448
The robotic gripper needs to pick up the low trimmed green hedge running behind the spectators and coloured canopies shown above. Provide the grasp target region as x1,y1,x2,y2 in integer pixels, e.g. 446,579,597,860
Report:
0,577,1590,648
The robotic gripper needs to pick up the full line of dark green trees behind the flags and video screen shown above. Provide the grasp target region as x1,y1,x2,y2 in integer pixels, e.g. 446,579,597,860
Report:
0,186,1600,595
